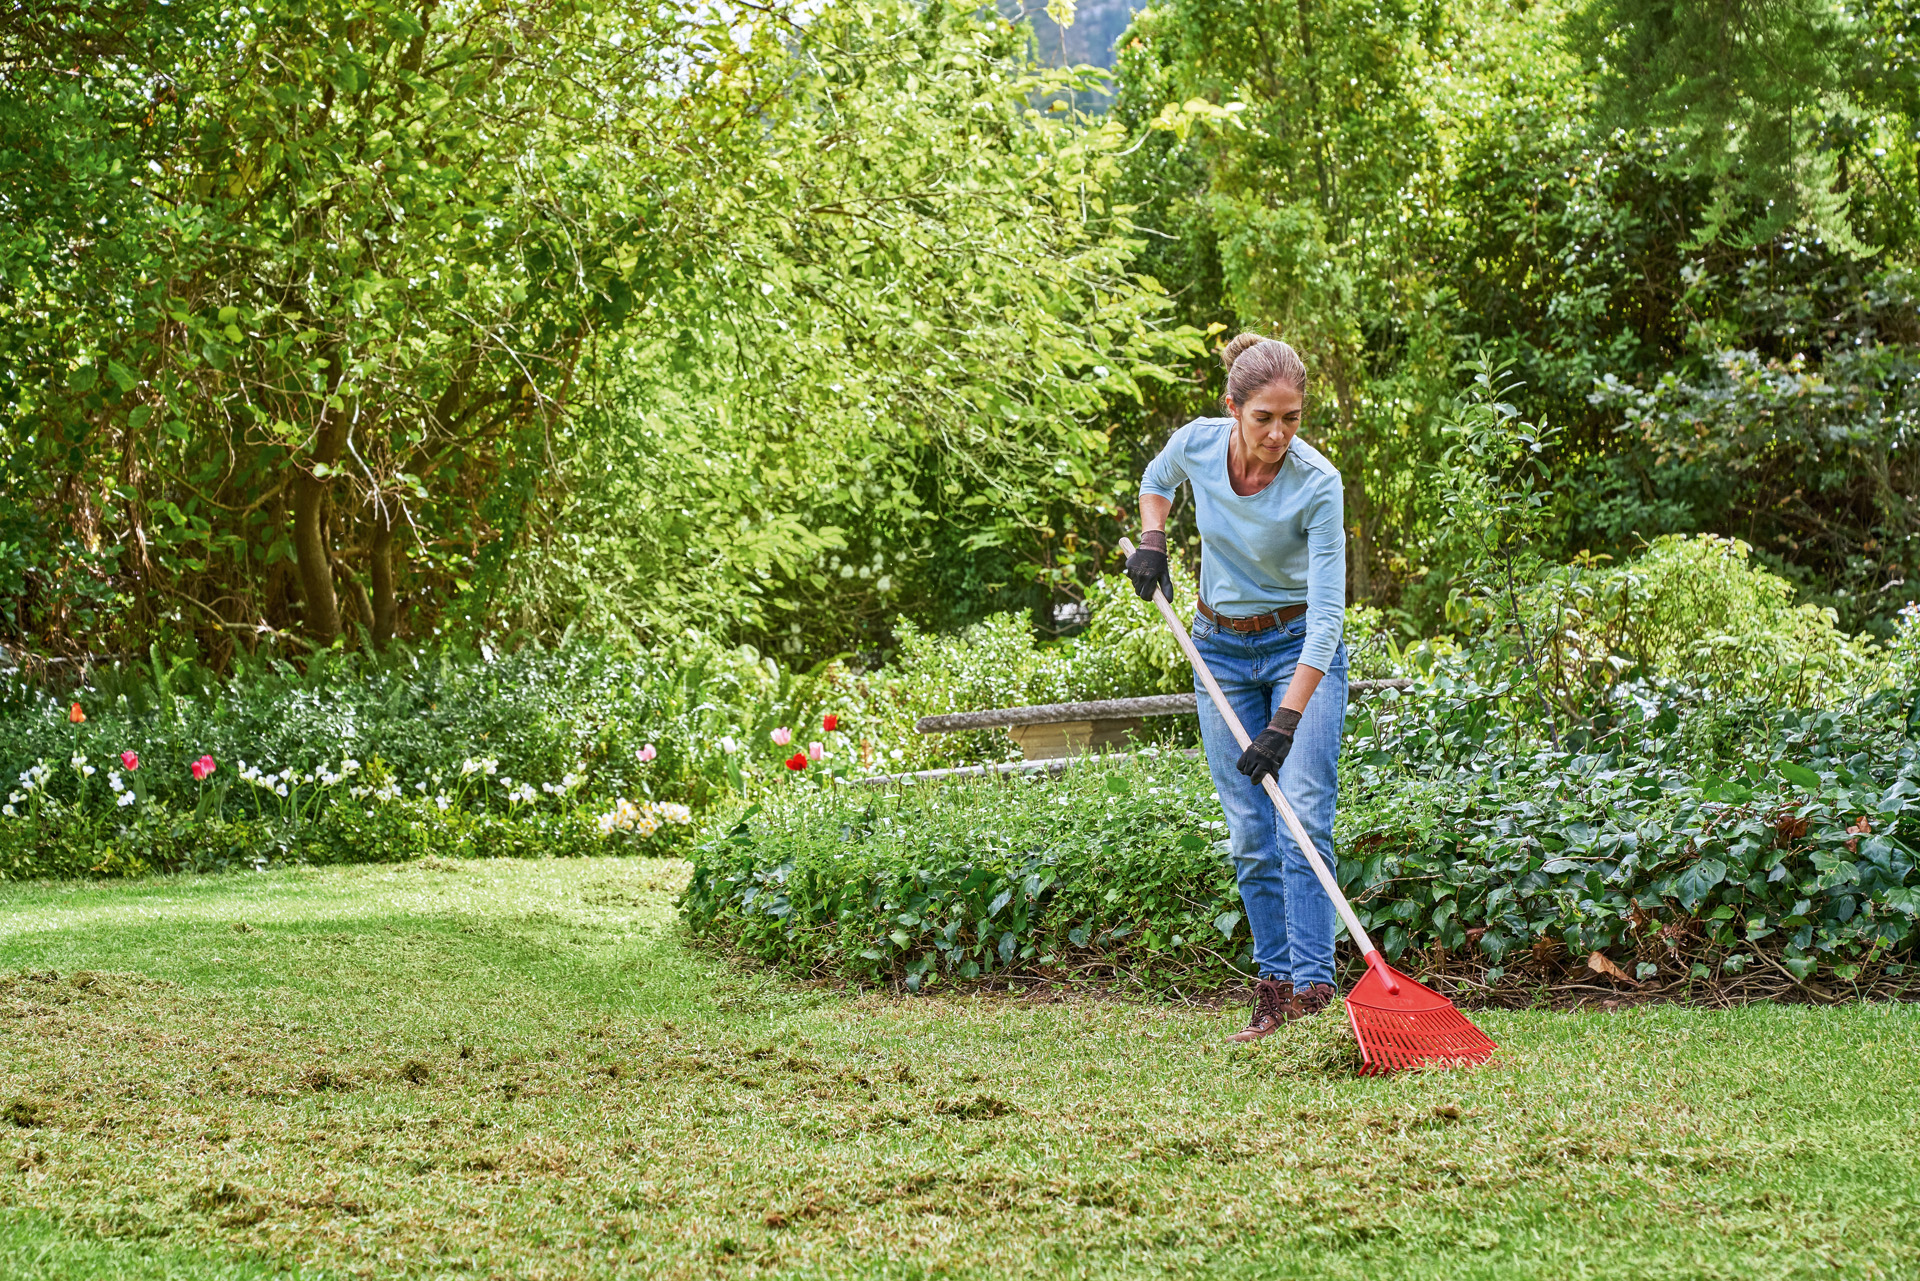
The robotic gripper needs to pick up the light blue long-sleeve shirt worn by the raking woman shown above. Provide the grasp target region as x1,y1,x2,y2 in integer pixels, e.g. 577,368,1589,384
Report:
1140,419,1346,672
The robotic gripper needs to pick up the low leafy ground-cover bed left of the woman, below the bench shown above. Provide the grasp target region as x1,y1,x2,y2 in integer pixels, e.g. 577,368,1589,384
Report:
682,755,1252,991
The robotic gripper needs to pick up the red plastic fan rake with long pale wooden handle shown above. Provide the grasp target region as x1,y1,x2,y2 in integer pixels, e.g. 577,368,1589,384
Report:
1119,538,1494,1074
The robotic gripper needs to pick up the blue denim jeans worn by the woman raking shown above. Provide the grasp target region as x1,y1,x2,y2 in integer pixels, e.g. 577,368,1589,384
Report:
1192,615,1346,985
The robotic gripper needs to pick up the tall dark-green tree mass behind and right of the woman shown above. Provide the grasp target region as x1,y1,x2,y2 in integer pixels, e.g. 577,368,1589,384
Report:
1116,0,1920,636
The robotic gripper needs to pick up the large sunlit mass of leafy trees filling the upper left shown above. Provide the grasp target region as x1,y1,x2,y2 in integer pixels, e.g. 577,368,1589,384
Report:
0,0,1194,666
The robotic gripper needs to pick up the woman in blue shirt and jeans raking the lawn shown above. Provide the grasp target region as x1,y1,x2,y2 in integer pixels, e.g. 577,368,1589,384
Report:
1127,334,1346,1041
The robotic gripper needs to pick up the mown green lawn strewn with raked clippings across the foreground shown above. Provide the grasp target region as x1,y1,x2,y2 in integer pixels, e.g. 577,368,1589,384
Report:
0,860,1920,1279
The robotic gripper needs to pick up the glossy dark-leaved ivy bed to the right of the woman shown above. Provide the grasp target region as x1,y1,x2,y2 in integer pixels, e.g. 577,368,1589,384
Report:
1340,686,1920,981
